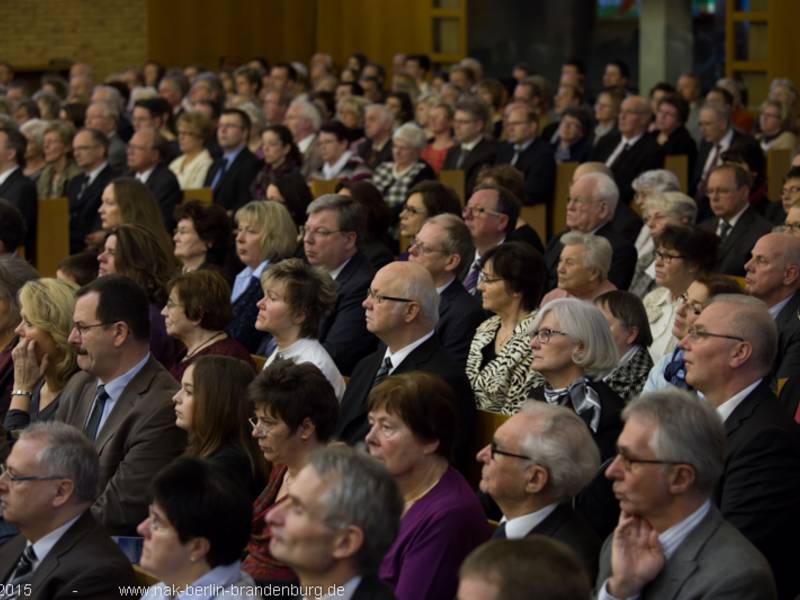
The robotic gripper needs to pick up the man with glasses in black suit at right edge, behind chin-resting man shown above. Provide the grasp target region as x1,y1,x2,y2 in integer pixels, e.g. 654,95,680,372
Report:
681,295,800,598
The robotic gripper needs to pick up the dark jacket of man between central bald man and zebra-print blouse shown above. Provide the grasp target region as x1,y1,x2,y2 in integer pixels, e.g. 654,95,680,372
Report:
436,279,486,367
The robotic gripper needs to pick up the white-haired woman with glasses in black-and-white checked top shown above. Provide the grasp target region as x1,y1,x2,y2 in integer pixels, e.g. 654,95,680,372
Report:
372,123,436,219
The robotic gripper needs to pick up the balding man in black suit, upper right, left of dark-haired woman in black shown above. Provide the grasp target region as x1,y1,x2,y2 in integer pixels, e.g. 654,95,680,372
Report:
592,96,664,204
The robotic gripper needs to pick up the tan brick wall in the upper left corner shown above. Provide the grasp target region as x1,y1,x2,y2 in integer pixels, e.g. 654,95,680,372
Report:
0,0,148,81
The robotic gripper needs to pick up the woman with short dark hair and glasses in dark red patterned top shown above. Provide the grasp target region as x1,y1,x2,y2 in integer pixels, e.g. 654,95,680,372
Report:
243,360,339,584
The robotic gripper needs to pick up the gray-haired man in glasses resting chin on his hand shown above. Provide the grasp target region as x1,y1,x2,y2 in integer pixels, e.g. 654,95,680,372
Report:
597,390,776,600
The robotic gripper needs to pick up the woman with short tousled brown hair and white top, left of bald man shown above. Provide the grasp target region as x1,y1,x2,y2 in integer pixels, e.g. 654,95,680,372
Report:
256,258,344,400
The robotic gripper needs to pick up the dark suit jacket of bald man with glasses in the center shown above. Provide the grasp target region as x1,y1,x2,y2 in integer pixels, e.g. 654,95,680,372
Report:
336,335,475,464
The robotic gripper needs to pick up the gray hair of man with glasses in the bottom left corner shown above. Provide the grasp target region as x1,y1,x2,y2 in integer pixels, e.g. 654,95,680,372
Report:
19,421,100,502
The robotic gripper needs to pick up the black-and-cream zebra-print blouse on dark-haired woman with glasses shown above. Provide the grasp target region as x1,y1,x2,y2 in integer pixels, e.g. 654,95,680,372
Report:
466,311,544,415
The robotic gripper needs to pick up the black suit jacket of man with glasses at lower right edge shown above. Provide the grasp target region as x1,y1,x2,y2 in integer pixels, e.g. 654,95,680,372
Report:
715,380,800,598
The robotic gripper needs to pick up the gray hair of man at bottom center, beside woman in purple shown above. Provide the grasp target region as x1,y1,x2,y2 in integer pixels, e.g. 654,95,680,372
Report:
307,444,403,575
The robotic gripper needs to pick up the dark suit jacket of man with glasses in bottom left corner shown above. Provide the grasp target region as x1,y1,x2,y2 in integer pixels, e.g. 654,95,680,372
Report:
0,510,134,600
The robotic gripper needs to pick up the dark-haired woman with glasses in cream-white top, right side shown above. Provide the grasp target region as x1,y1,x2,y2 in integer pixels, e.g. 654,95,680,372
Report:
643,225,719,362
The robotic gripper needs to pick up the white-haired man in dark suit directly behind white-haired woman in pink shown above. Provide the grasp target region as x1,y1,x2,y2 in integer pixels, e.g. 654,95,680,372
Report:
544,173,636,290
